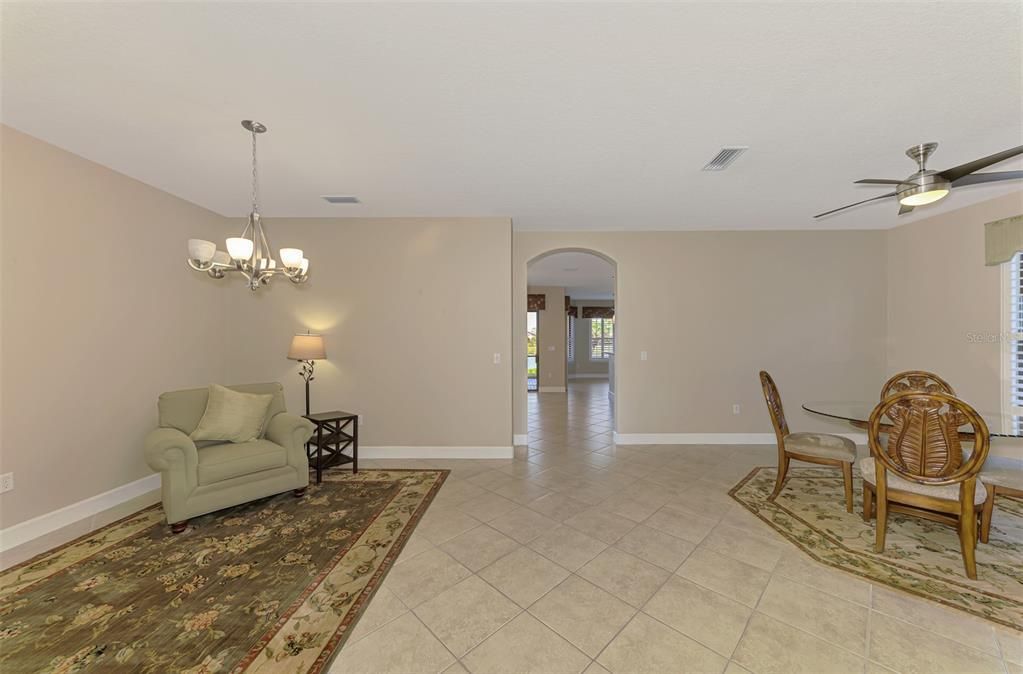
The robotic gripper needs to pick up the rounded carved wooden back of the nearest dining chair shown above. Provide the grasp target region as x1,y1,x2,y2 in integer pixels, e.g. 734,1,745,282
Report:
868,391,990,486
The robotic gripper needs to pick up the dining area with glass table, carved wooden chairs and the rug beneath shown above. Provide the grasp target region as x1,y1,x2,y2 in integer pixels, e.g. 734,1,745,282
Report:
729,370,1023,630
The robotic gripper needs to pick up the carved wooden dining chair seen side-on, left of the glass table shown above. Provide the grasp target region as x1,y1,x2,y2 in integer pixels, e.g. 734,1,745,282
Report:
760,370,856,512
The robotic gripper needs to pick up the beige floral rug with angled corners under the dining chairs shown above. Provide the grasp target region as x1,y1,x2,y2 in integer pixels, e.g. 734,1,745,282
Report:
729,467,1023,630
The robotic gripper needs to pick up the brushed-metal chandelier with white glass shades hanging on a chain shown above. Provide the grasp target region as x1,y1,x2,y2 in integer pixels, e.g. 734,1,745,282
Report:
188,120,309,290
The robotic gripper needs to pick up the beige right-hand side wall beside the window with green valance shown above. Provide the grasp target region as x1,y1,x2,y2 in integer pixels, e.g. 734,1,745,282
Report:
886,191,1023,451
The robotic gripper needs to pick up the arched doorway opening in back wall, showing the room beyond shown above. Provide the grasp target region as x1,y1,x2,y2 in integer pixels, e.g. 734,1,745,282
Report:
515,249,619,451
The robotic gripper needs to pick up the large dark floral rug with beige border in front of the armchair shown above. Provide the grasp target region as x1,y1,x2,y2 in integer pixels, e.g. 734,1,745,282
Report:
0,470,447,674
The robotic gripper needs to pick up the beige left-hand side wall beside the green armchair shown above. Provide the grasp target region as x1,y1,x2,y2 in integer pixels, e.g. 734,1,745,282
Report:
0,126,228,528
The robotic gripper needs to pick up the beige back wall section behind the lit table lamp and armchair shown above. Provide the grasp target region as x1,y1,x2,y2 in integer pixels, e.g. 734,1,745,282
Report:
222,218,515,447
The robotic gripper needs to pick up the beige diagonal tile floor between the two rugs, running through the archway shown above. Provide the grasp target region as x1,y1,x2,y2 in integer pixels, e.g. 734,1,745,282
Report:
330,381,1023,674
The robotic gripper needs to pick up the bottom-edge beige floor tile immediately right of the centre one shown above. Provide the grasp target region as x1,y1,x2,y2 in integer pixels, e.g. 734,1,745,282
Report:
596,613,727,674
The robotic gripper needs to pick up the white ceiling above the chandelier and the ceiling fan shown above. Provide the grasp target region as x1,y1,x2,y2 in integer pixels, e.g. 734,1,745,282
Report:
2,1,1023,229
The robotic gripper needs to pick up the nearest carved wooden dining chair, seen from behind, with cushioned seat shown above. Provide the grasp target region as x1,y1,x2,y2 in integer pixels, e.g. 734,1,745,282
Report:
859,391,990,579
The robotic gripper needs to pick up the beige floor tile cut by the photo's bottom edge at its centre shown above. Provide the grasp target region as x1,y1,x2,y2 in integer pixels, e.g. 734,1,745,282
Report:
461,613,590,674
